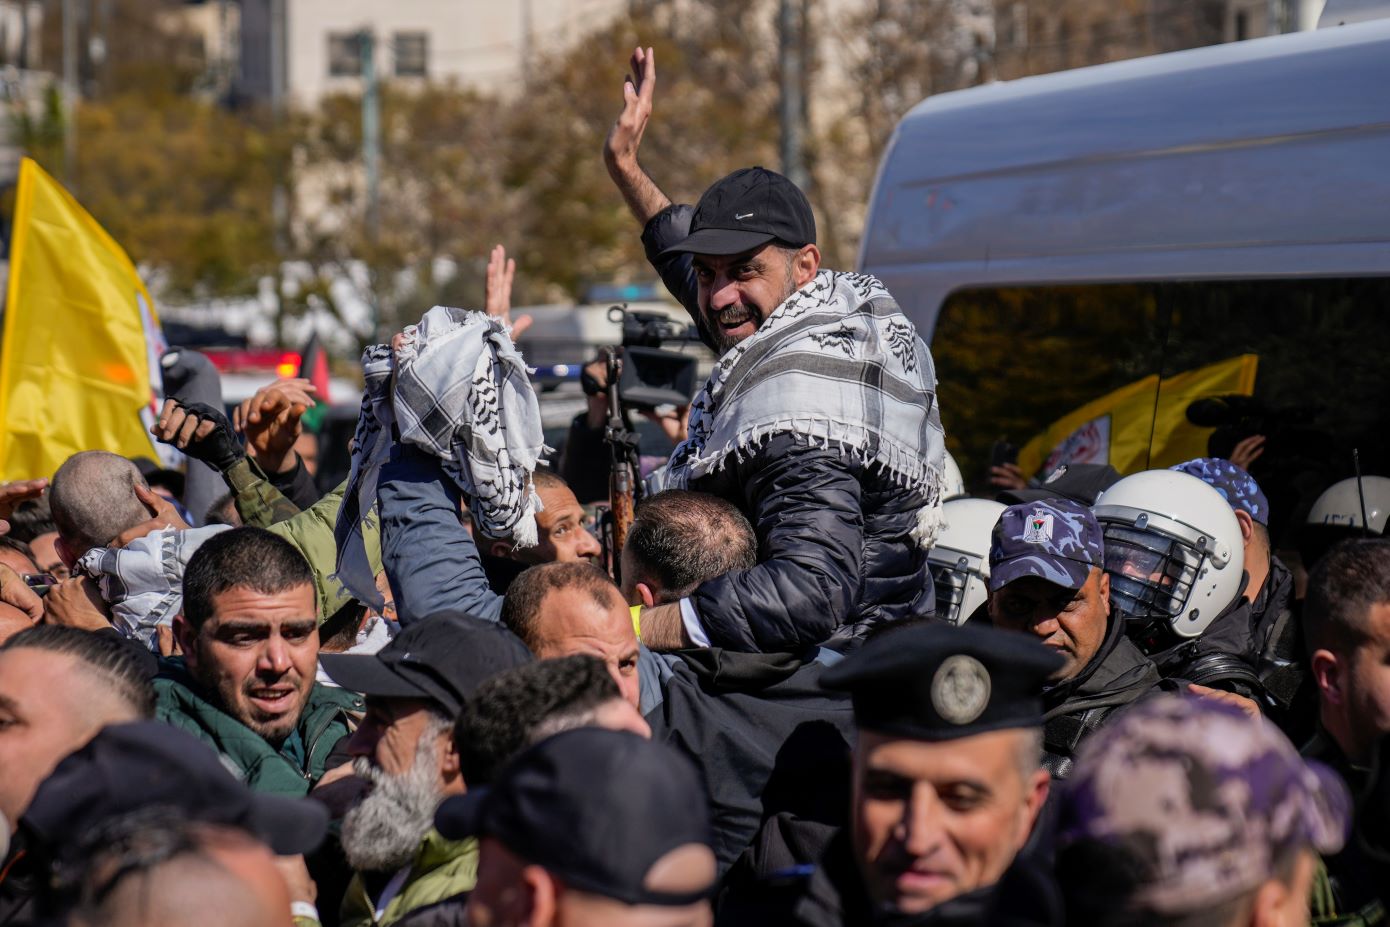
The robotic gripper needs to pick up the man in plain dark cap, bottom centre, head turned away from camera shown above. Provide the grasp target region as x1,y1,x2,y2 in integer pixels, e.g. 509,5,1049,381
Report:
436,728,714,927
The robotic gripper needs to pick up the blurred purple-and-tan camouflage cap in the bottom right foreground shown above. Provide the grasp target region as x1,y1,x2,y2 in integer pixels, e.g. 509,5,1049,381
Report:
1058,695,1351,914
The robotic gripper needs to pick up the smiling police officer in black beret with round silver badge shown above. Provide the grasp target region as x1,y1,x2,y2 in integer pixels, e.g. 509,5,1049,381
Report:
719,624,1061,927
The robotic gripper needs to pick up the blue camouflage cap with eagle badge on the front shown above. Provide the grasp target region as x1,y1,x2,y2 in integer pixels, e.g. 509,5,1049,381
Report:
990,499,1105,592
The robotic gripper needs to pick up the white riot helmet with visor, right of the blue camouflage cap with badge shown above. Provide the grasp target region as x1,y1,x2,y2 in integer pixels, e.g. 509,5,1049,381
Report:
1094,470,1245,638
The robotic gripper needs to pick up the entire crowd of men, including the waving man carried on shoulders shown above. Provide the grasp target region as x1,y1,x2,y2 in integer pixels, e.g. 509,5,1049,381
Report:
0,49,1390,927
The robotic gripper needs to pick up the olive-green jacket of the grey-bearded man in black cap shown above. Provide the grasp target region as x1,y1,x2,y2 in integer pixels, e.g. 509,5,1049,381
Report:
339,830,478,927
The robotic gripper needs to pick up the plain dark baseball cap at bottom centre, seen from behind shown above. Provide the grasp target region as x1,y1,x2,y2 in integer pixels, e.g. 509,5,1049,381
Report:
435,727,714,906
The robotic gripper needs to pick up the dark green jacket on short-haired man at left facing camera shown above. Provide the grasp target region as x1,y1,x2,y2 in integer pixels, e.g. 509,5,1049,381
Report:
154,657,366,796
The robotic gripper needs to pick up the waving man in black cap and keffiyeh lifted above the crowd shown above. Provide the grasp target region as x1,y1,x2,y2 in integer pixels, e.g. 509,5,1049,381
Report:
605,49,945,652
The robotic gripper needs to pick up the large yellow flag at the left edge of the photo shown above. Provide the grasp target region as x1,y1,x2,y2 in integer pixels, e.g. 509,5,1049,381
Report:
0,158,164,479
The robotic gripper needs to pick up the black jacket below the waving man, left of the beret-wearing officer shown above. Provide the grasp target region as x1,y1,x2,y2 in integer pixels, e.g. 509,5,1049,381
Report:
648,649,855,873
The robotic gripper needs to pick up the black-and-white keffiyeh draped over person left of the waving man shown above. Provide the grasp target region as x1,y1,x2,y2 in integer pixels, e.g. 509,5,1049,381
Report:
335,306,546,605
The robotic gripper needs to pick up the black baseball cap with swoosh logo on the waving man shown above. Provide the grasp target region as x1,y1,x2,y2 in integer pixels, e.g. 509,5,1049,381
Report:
662,167,816,256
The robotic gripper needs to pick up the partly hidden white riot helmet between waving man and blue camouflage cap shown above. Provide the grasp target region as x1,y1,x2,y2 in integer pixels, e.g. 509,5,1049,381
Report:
927,498,1005,624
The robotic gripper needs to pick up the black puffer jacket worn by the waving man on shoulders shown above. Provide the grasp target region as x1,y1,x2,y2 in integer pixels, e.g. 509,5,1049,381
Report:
642,206,935,653
